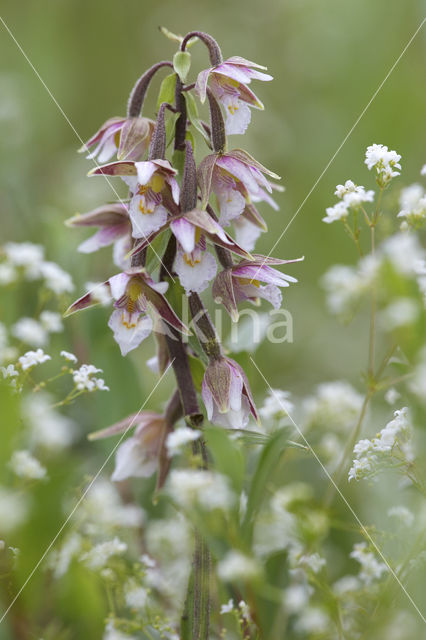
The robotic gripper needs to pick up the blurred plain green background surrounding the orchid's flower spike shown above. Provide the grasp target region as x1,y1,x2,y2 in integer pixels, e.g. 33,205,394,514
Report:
0,0,426,640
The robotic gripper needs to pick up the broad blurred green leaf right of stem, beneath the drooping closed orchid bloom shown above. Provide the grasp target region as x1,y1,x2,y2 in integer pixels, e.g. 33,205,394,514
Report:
204,426,245,494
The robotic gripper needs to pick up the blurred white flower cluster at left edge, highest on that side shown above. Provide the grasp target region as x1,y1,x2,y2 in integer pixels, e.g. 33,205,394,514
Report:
0,242,74,295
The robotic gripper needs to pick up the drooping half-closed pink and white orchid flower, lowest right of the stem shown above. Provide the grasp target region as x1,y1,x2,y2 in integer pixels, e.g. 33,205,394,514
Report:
201,357,259,429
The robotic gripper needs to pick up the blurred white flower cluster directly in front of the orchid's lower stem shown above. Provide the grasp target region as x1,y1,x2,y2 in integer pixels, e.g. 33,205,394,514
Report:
168,469,235,511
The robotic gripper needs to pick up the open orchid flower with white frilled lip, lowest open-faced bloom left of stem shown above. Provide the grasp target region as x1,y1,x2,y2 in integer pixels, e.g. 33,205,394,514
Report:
65,268,188,356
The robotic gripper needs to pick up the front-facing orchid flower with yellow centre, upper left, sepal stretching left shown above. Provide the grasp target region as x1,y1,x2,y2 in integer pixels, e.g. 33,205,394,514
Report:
89,160,179,238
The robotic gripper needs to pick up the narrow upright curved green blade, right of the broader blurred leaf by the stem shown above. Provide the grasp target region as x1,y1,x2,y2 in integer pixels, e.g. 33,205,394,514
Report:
243,427,289,541
